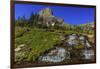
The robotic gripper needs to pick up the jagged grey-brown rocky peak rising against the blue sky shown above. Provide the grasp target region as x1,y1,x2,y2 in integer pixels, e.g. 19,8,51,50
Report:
36,8,64,27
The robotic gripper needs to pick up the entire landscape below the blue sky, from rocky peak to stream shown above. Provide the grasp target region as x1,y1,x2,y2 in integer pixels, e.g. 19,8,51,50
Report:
14,8,95,65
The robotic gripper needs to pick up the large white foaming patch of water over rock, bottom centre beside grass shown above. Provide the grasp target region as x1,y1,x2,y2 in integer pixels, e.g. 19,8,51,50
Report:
39,47,70,63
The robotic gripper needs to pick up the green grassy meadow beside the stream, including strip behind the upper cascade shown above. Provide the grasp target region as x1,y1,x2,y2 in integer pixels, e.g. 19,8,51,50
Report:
15,27,94,61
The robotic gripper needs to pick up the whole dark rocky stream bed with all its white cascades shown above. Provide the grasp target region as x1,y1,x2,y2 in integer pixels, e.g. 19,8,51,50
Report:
39,34,95,63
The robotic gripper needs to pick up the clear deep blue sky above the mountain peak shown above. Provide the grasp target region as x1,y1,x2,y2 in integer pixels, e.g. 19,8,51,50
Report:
15,4,95,25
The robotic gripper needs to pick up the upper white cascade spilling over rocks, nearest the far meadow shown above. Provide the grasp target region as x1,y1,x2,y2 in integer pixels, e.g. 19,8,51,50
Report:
64,34,92,48
